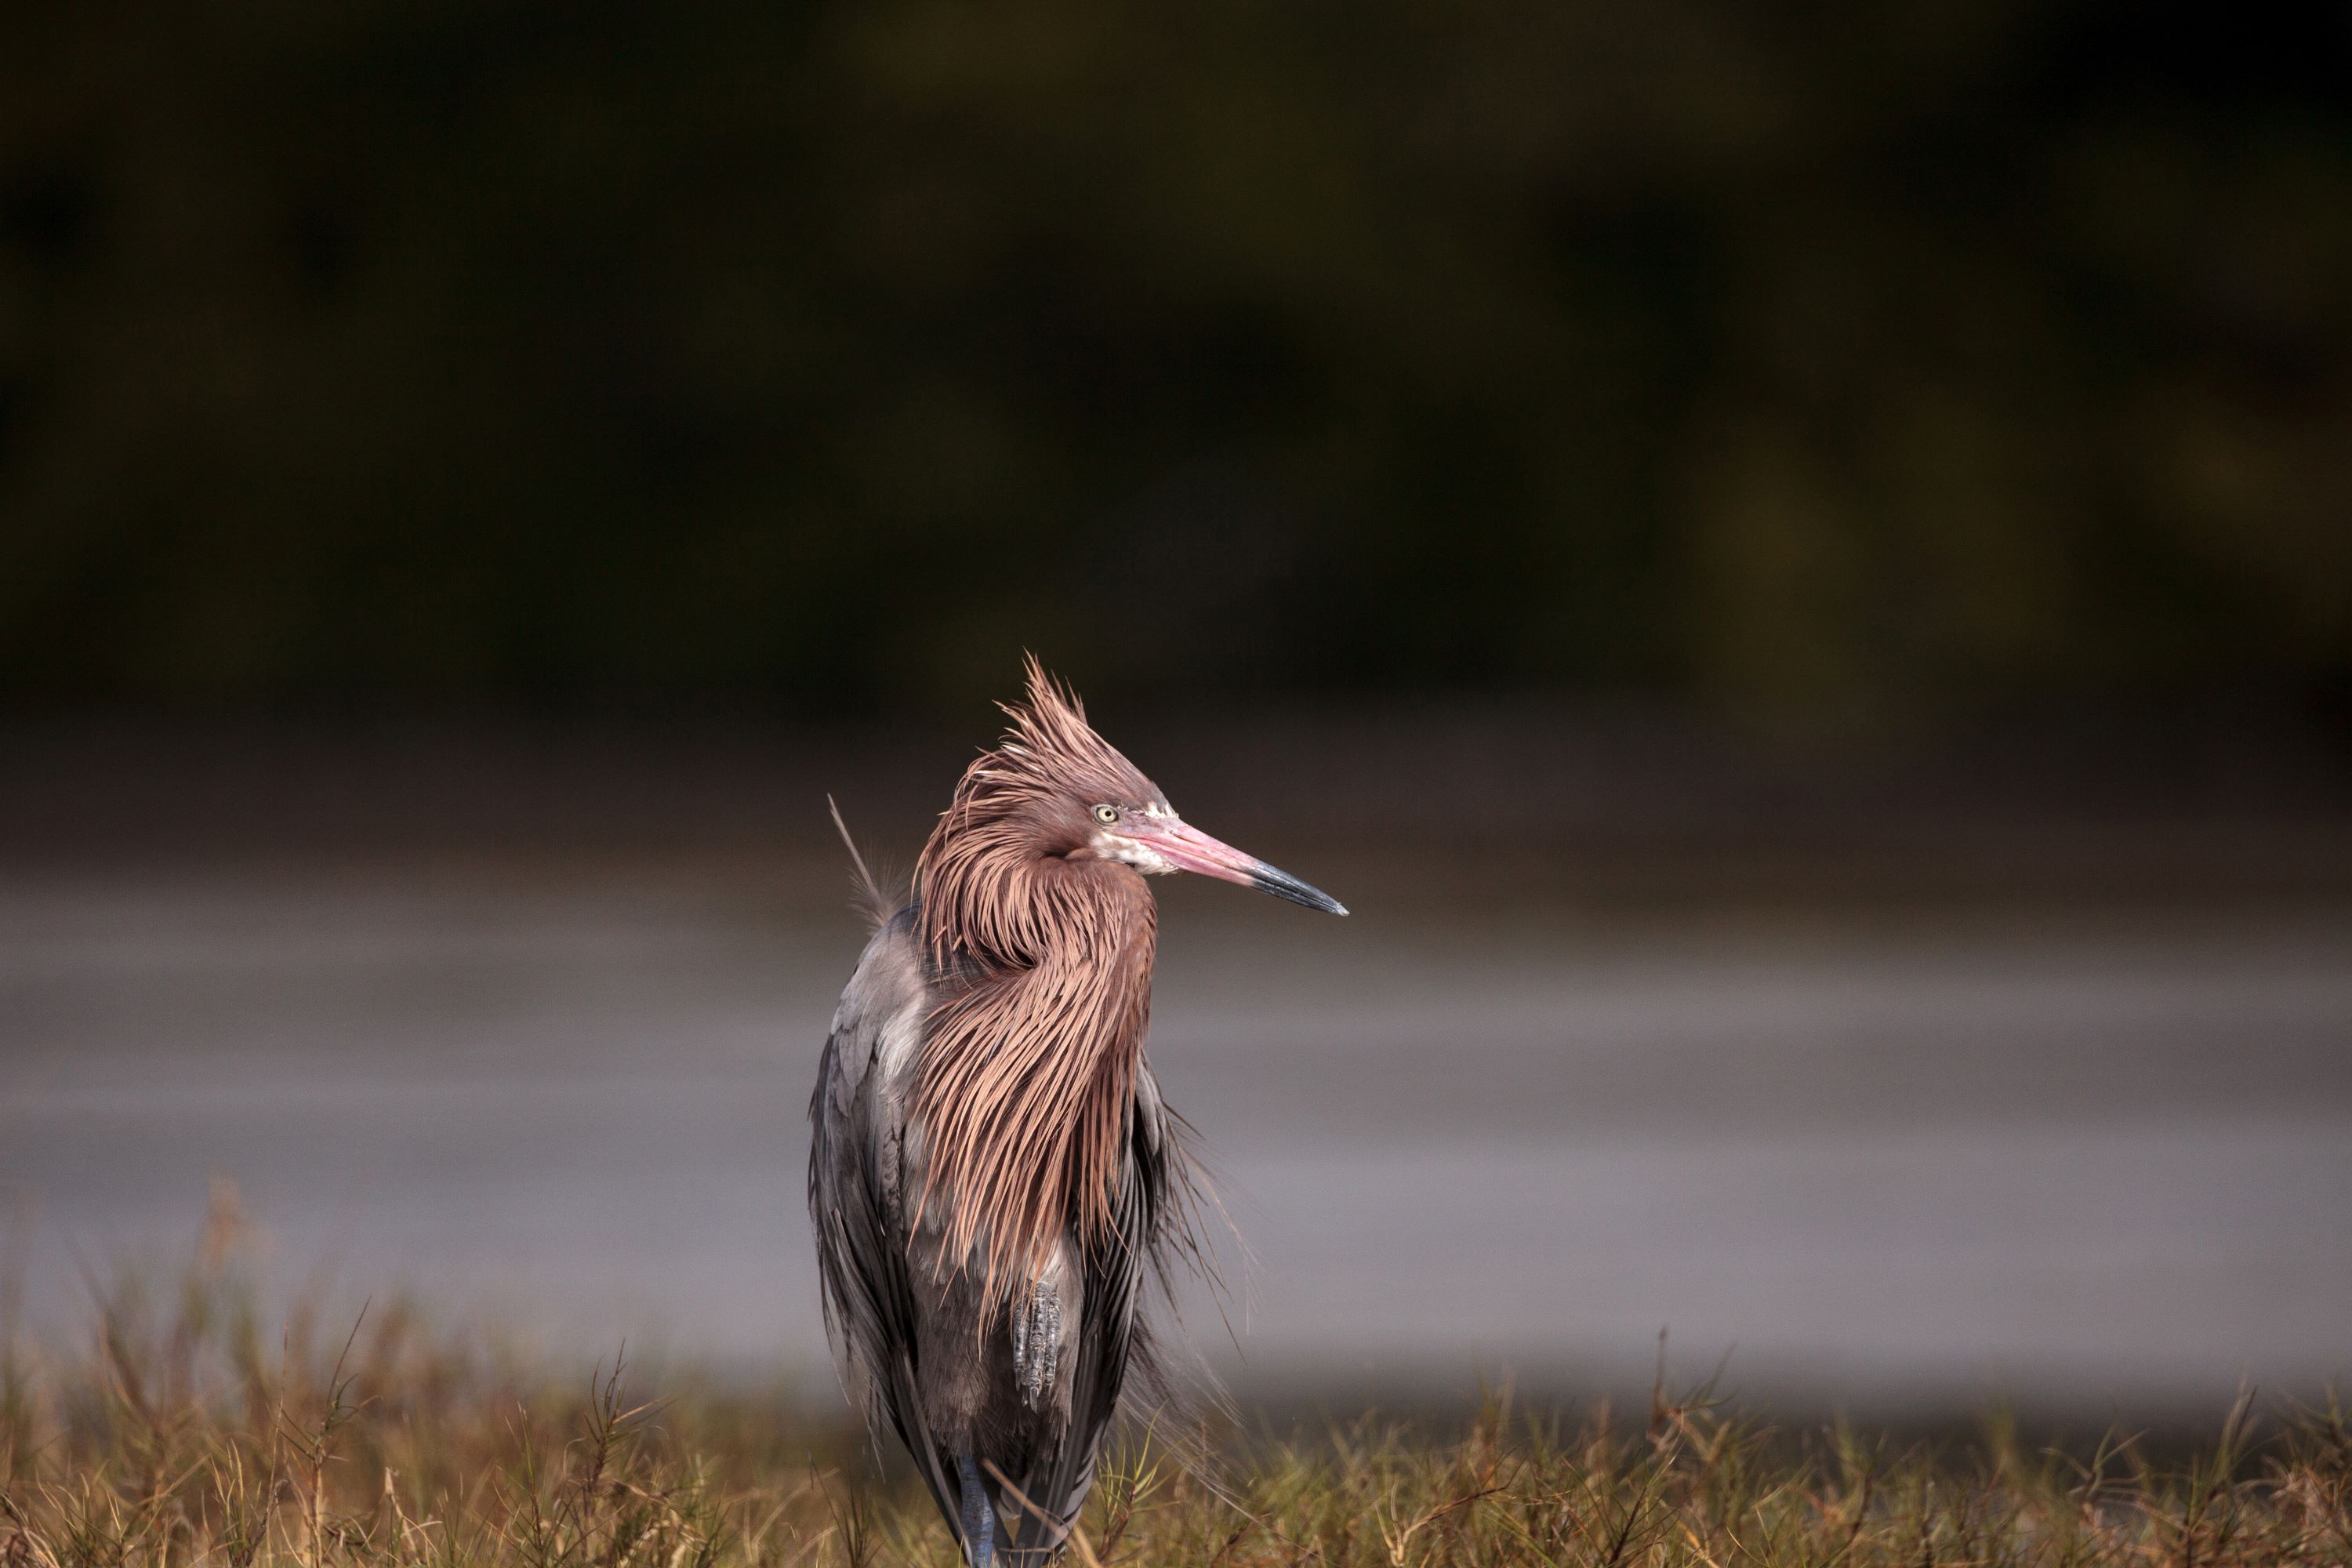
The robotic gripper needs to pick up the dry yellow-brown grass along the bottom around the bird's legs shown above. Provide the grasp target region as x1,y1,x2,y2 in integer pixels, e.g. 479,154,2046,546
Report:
0,1258,2352,1568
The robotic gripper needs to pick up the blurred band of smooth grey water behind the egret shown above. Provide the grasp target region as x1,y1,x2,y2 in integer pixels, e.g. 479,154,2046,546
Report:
0,867,2352,1410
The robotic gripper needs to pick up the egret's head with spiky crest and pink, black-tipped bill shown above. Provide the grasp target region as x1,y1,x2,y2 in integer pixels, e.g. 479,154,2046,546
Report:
917,656,1348,964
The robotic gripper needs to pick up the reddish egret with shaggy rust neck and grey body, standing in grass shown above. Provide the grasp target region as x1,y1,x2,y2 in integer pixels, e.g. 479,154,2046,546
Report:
809,656,1348,1568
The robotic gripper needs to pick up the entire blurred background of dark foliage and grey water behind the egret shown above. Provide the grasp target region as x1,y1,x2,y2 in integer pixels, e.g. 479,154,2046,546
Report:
0,0,2352,1420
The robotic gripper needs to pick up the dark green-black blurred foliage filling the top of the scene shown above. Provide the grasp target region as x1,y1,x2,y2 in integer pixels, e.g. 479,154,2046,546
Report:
0,0,2352,708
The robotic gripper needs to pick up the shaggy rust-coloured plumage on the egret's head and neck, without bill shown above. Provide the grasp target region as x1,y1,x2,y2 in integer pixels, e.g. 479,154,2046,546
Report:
915,659,1160,1300
